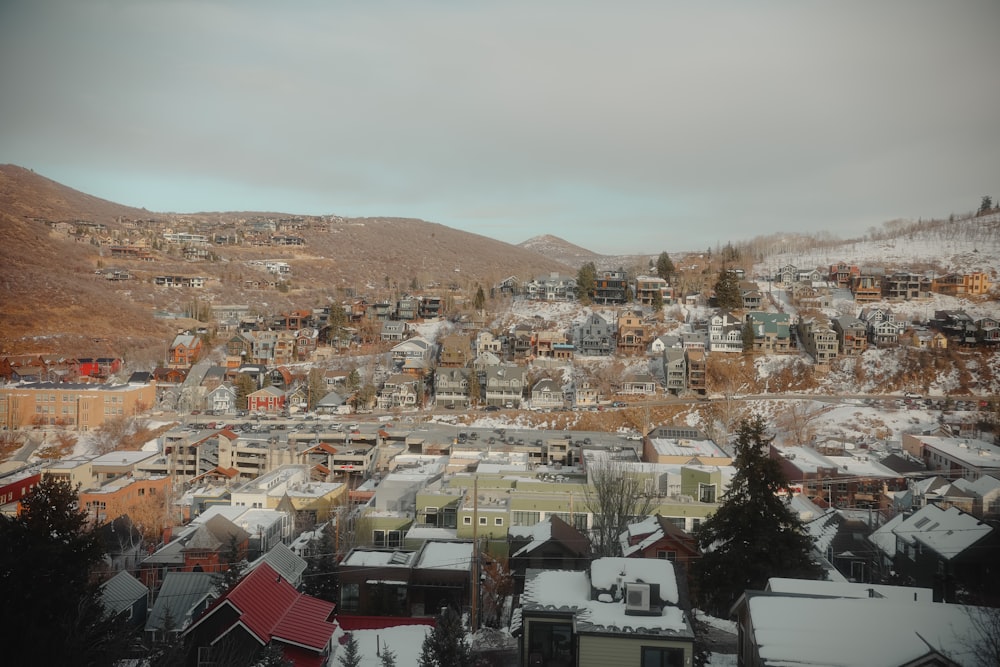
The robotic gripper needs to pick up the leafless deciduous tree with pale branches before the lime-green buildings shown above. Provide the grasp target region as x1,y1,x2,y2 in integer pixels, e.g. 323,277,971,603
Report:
584,459,655,558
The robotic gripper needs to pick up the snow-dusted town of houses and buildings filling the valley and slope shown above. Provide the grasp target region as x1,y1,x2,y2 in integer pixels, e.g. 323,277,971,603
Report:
0,226,1000,666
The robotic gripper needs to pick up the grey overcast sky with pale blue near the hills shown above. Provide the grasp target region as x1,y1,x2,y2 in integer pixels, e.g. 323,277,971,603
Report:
0,0,1000,253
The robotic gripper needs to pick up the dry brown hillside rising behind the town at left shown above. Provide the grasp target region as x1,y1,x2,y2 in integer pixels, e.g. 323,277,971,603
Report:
0,165,573,359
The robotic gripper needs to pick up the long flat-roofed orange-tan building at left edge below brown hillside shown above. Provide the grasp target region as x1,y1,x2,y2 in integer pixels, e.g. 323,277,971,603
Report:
0,382,156,431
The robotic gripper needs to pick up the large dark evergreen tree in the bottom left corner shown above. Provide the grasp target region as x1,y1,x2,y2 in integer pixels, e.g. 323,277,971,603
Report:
0,477,130,665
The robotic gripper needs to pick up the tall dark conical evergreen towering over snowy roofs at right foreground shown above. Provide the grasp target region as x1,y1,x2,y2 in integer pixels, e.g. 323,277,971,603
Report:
693,415,822,616
